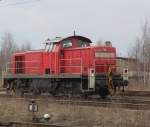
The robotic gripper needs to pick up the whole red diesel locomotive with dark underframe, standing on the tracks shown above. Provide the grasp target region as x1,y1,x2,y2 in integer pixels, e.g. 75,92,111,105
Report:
3,36,128,97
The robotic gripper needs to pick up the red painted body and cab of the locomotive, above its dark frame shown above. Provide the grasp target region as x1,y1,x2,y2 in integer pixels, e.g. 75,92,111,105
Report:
12,36,116,75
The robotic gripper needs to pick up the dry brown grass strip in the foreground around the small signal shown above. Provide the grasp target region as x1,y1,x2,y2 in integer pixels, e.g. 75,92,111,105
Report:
0,99,150,127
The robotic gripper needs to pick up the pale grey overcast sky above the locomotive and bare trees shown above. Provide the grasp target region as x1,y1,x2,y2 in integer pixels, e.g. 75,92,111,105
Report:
0,0,150,55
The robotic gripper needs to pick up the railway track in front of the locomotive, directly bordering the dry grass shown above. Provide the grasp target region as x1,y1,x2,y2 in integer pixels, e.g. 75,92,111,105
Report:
0,97,150,110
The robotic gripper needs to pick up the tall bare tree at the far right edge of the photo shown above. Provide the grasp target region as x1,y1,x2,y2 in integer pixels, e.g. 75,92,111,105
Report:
130,20,150,85
